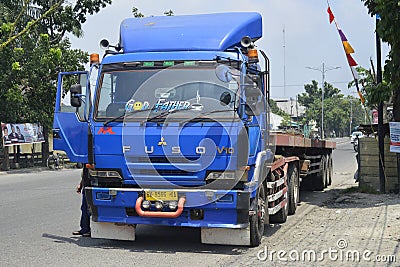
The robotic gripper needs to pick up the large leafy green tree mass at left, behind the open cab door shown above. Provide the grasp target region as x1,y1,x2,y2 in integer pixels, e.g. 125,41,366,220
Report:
0,0,111,163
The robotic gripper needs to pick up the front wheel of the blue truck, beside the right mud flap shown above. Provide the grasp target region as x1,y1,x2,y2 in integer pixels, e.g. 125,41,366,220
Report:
249,184,268,247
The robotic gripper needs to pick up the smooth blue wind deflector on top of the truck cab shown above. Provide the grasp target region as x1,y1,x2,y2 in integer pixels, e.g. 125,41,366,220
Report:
120,12,262,53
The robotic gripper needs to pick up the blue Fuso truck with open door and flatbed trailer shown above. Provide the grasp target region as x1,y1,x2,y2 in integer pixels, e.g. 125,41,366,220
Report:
53,12,335,246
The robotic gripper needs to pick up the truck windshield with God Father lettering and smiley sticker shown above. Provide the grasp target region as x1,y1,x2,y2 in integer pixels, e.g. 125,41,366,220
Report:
94,62,239,121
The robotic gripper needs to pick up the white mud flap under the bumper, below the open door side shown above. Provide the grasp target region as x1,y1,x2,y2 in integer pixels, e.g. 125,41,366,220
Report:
90,222,136,241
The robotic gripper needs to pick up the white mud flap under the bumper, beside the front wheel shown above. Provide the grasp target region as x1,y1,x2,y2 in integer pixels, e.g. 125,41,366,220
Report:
201,227,250,246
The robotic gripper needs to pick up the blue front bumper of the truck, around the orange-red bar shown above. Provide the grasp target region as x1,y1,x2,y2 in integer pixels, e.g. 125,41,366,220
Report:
85,187,250,228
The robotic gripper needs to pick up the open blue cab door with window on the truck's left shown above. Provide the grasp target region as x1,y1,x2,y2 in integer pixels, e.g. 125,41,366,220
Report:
53,71,91,163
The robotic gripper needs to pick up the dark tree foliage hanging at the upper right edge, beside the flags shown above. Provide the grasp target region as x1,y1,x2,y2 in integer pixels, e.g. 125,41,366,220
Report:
361,0,400,121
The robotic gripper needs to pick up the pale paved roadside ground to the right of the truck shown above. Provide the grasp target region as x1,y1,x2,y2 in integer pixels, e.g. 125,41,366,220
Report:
220,166,400,266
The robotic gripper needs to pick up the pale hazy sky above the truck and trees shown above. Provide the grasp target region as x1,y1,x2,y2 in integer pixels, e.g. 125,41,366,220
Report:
70,0,389,99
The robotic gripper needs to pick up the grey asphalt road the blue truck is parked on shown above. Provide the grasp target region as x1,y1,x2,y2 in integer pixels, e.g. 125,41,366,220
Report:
0,139,356,266
